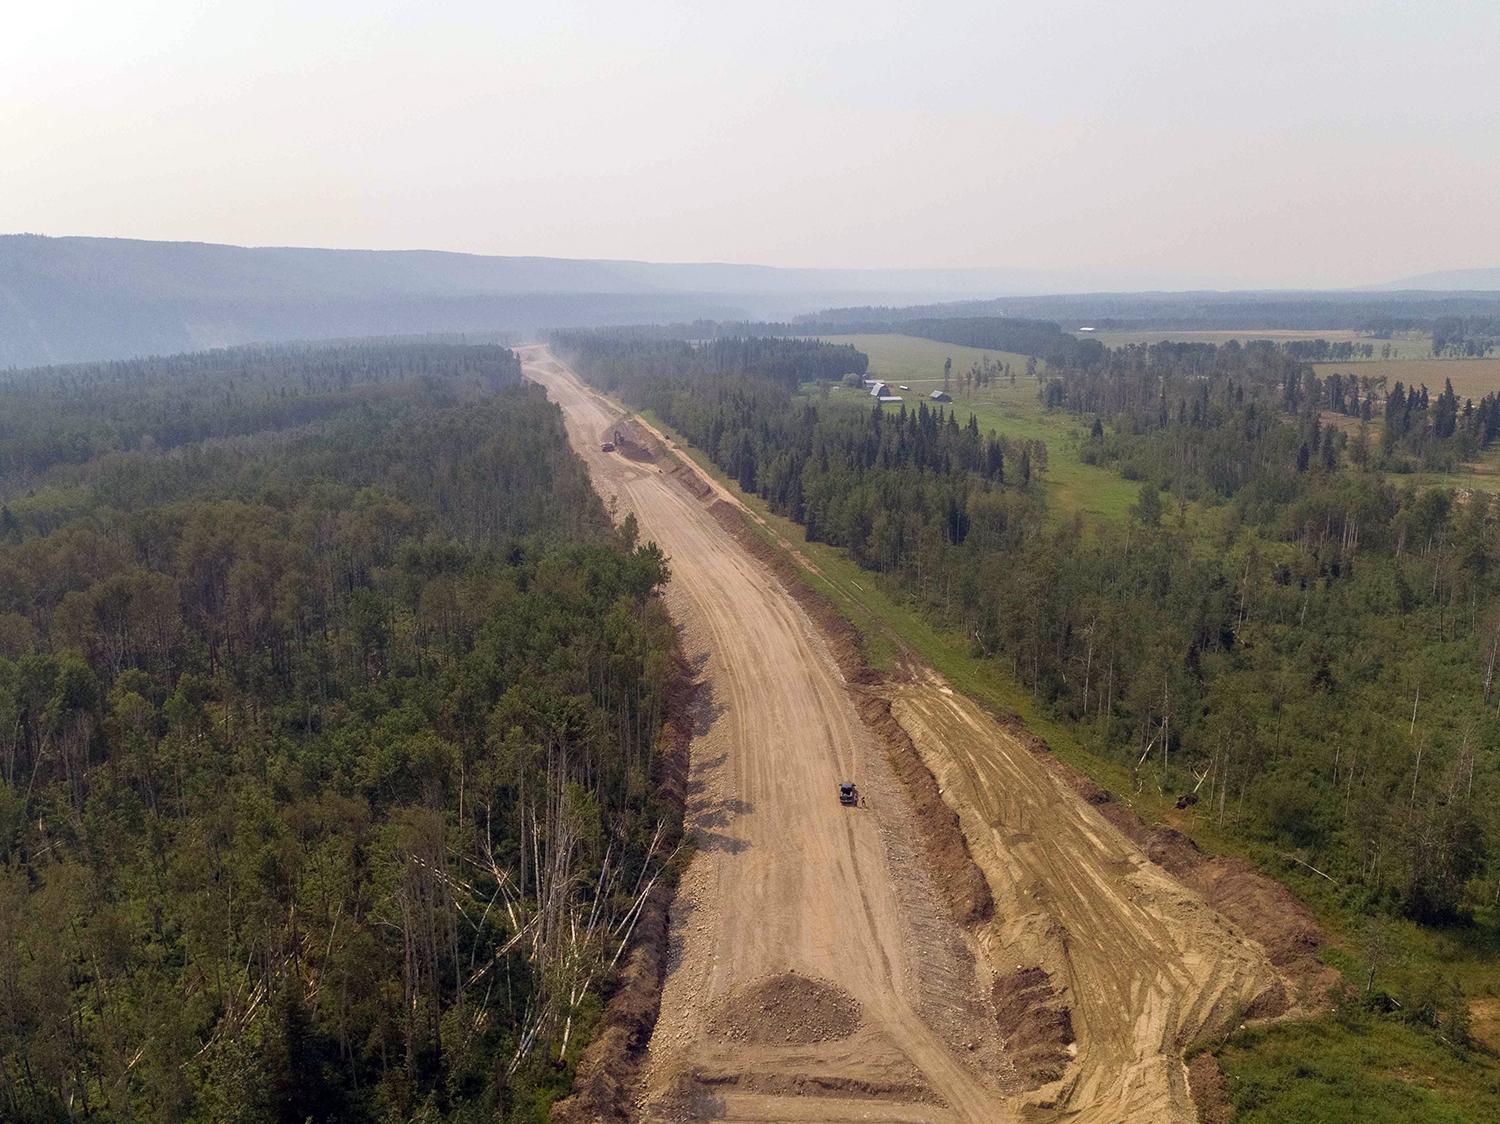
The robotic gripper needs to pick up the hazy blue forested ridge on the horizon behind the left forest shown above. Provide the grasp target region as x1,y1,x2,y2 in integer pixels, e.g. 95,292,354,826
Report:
0,234,1056,369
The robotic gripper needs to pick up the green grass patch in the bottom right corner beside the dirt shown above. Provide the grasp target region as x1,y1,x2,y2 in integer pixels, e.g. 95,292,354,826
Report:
1218,1014,1500,1124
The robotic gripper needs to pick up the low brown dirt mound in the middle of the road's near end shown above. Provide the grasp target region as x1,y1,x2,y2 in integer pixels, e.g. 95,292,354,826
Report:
708,972,860,1046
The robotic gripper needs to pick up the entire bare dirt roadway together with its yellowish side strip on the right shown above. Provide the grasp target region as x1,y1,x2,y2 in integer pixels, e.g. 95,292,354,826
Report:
522,348,1275,1121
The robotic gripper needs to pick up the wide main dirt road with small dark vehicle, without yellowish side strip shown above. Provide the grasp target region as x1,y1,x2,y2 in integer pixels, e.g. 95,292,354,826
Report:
524,351,1008,1121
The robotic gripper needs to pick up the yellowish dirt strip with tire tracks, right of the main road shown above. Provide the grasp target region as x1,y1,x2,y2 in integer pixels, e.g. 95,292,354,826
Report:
881,675,1283,1121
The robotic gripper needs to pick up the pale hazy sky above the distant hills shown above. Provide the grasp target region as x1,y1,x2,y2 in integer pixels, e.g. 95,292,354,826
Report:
0,0,1500,285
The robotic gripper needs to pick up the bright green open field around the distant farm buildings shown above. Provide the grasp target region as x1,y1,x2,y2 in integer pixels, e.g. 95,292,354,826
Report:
825,335,1140,521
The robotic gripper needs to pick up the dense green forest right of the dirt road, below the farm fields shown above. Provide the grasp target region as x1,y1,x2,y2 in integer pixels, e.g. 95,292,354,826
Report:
555,335,1500,948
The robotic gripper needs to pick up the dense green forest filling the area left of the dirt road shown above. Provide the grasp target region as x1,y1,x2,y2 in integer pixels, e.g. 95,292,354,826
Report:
0,342,672,1124
